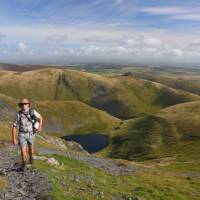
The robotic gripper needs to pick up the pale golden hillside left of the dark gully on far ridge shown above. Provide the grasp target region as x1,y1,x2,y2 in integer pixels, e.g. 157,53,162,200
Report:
0,70,59,100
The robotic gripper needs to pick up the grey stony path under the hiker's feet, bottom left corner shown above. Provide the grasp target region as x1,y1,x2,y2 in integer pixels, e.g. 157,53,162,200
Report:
0,147,51,200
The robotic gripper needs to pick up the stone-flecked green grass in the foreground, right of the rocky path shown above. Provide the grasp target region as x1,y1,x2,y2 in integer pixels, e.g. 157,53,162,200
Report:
37,155,200,200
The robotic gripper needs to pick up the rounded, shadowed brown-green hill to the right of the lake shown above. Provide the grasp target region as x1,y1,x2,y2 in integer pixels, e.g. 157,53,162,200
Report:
109,101,200,160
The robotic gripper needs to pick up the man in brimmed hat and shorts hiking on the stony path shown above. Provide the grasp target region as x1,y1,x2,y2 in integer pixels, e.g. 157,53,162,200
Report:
12,99,42,171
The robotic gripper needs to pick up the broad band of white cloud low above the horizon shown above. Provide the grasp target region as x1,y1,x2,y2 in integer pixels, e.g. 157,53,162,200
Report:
0,26,200,63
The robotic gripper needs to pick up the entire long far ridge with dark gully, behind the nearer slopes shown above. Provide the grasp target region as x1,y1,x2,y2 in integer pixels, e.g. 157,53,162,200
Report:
0,69,199,119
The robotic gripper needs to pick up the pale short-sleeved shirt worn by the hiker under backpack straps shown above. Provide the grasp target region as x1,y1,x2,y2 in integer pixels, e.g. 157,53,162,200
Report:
13,108,40,133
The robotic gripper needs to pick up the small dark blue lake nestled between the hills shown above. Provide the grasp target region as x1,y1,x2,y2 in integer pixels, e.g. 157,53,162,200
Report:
63,134,109,153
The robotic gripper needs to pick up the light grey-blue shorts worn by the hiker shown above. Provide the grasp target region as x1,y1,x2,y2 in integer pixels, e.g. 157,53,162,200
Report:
18,132,35,148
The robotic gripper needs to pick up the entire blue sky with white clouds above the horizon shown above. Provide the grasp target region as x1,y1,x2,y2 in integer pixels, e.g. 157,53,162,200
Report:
0,0,200,64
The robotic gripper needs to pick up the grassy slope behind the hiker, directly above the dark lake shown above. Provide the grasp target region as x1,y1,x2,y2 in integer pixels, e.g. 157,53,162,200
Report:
0,94,120,136
